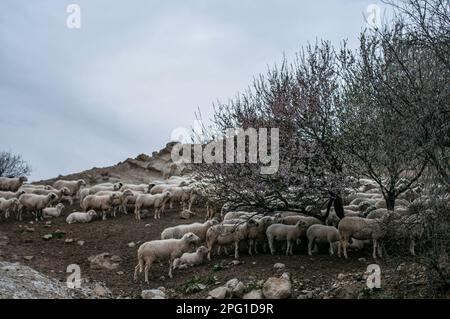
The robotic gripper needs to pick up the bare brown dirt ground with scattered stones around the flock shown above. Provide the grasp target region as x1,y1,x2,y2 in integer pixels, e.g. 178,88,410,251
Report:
0,202,442,298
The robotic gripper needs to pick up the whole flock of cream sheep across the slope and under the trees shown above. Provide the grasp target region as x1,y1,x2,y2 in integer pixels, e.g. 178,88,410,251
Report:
0,176,436,283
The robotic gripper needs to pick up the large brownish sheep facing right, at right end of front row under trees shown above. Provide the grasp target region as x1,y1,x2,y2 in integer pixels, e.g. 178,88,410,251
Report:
338,212,390,259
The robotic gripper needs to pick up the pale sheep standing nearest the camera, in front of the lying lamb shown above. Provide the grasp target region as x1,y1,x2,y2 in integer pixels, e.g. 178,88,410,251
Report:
134,233,199,283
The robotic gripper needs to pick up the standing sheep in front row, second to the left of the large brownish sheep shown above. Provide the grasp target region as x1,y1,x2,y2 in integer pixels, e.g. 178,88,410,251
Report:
266,220,305,255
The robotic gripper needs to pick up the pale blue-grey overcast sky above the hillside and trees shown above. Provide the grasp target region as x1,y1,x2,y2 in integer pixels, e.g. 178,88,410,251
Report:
0,0,382,180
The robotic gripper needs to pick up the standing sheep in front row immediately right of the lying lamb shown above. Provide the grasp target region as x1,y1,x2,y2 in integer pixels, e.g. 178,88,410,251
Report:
206,219,258,260
